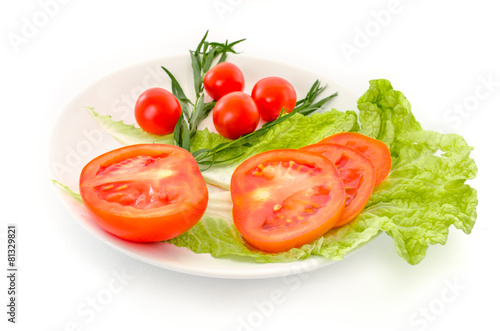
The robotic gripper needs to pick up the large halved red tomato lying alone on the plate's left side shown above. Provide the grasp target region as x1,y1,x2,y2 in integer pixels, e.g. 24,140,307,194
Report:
80,144,208,242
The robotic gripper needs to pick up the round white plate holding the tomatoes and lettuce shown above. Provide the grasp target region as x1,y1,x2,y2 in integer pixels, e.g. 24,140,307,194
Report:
49,55,358,278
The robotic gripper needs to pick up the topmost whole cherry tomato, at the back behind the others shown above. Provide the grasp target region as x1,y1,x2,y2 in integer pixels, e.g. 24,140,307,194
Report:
203,62,245,101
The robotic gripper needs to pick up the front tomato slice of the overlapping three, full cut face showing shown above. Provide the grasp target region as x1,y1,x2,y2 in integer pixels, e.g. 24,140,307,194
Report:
231,149,345,252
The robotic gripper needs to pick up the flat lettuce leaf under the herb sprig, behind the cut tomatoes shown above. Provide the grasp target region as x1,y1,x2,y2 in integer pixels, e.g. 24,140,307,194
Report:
87,108,358,190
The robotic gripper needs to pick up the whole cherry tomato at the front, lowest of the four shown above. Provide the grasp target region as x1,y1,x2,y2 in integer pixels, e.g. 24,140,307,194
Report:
212,92,259,139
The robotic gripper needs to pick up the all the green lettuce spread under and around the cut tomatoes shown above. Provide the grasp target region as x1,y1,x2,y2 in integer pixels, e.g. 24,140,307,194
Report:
76,79,478,264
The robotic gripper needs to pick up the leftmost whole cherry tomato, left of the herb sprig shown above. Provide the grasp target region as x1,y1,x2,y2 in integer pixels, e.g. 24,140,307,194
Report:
135,87,182,135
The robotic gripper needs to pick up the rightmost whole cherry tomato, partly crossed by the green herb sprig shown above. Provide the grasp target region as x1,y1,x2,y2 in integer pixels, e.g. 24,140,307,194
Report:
252,77,297,121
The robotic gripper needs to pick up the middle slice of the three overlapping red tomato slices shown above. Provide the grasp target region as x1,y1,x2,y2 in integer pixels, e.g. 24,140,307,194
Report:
303,143,376,226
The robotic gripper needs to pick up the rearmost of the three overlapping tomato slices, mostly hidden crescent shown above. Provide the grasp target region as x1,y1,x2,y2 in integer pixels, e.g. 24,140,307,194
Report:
319,132,392,186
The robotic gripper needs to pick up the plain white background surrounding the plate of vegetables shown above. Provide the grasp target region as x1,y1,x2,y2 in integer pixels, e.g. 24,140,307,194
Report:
0,0,500,331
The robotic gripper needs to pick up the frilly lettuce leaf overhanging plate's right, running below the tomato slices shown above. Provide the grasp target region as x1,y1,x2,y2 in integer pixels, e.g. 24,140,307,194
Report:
167,80,478,264
